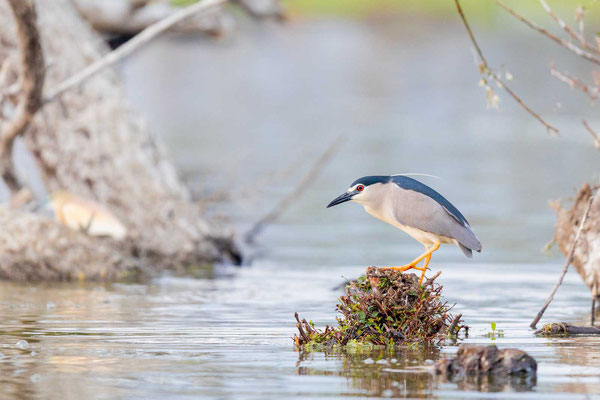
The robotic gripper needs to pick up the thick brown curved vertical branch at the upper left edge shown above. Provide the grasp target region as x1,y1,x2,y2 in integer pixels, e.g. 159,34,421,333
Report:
0,0,45,196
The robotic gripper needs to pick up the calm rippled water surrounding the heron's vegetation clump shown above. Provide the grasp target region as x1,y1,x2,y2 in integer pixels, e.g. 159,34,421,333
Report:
0,14,600,399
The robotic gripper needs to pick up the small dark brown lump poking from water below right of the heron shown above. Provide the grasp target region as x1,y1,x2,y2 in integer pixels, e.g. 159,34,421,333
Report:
434,344,537,380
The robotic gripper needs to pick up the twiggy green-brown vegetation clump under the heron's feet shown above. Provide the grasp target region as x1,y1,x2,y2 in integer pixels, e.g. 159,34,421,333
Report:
294,267,468,350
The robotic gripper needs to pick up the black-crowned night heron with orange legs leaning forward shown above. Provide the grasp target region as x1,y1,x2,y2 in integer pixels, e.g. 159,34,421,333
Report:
327,175,481,283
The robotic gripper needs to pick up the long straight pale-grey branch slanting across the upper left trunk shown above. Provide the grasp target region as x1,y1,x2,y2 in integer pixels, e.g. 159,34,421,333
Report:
44,0,227,103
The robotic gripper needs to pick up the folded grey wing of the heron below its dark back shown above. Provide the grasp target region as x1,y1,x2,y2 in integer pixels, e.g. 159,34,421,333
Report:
390,185,481,255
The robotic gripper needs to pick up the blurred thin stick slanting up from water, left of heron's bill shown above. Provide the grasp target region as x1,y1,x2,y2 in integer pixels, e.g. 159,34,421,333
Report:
244,137,343,243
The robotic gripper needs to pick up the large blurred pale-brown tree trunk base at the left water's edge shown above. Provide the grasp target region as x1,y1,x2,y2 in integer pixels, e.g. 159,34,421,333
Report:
0,0,253,280
